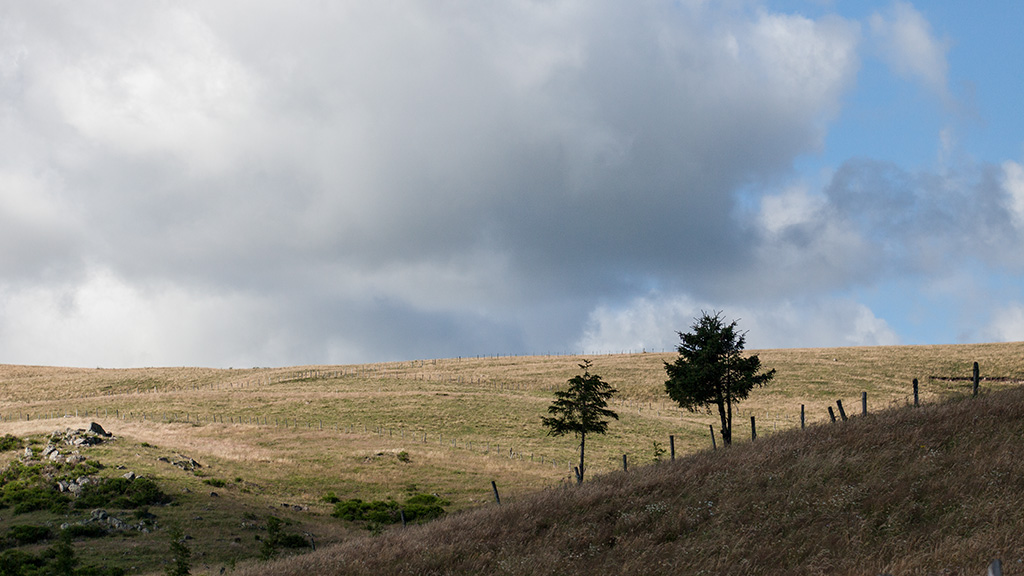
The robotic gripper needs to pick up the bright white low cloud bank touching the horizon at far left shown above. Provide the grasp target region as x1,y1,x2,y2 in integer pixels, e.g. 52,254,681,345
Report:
0,271,280,367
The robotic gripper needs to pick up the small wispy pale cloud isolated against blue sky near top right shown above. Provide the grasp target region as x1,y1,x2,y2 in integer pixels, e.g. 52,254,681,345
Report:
869,1,949,96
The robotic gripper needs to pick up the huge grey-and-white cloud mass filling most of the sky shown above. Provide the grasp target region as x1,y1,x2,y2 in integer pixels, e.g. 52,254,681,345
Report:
0,2,872,364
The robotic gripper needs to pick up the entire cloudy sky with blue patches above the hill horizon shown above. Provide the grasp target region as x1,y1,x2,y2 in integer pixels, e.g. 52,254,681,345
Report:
0,0,1024,367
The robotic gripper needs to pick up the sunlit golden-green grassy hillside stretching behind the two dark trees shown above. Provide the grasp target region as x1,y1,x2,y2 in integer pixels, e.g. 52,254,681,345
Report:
0,343,1024,574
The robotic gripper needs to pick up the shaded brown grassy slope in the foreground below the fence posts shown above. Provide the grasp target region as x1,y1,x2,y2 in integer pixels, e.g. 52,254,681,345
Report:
238,381,1024,576
